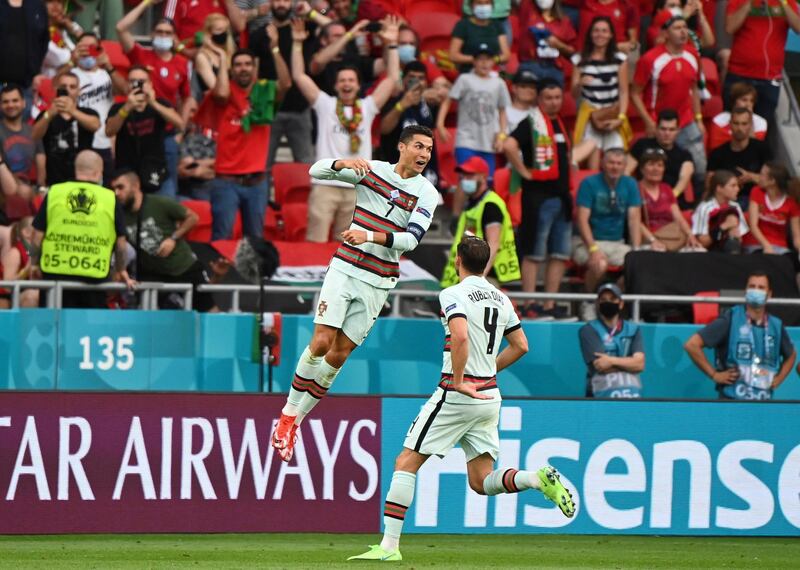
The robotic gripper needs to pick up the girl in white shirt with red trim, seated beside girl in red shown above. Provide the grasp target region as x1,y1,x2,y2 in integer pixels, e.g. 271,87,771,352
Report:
692,170,750,253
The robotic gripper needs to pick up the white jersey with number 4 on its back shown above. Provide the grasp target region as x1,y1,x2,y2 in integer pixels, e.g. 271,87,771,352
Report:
439,275,520,404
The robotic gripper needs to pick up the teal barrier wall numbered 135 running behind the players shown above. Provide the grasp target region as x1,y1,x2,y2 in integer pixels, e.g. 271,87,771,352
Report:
0,309,800,400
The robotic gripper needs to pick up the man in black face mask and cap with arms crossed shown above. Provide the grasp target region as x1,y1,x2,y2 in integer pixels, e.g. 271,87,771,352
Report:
578,283,645,398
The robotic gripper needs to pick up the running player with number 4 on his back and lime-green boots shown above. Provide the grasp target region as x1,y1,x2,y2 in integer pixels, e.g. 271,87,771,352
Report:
348,236,575,561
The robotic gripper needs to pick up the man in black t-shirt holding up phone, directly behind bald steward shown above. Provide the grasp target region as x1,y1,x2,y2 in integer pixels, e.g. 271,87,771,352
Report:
32,71,100,186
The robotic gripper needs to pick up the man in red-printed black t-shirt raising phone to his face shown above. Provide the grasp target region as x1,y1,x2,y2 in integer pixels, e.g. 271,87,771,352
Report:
106,65,183,192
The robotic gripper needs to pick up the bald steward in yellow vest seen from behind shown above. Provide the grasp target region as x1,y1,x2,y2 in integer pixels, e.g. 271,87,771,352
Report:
31,150,133,307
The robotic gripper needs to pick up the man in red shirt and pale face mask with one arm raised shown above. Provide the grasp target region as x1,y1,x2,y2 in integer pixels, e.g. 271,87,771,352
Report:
117,0,194,197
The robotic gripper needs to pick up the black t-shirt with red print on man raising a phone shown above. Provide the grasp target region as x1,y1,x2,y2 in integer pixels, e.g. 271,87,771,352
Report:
108,98,172,183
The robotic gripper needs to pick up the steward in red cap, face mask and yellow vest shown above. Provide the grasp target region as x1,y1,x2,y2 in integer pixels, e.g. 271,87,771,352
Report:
441,156,521,287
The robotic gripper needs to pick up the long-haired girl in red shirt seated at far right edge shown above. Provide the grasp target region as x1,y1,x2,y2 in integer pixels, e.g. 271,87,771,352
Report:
742,161,800,253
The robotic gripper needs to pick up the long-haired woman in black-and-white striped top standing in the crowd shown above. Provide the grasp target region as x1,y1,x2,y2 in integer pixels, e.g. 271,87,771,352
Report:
572,16,633,170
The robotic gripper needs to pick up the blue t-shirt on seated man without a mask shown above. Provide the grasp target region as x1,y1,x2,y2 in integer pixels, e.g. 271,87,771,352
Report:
578,173,642,241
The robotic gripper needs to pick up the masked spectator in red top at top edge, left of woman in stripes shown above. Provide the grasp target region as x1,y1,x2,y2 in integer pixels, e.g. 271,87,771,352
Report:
517,0,577,85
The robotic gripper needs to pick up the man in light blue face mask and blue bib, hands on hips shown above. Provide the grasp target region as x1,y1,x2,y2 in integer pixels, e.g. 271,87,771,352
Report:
684,271,797,400
